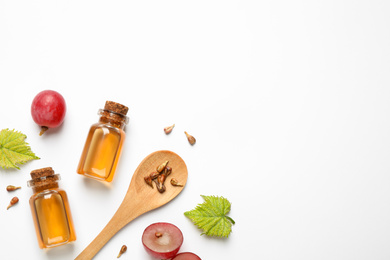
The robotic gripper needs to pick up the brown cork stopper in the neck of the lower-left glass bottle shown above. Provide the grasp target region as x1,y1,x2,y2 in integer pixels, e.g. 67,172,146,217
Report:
27,167,60,191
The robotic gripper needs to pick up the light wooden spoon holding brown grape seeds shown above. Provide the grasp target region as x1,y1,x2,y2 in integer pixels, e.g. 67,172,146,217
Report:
75,151,188,260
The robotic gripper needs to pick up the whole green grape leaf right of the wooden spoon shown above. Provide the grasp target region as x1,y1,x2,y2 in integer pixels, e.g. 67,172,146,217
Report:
184,195,235,237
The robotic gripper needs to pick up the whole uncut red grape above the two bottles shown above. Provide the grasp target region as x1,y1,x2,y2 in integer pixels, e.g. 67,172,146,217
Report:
31,90,66,135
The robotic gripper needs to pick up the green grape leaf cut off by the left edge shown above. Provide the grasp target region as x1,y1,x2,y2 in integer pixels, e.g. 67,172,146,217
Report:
0,128,40,169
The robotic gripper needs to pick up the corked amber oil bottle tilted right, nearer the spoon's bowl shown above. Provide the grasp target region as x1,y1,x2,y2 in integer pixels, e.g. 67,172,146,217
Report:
77,101,129,182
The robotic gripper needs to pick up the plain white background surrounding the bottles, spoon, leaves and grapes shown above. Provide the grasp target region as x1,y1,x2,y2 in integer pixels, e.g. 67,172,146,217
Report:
0,0,390,260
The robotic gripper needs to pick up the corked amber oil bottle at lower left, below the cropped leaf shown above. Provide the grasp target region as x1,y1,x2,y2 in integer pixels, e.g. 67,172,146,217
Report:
27,167,76,248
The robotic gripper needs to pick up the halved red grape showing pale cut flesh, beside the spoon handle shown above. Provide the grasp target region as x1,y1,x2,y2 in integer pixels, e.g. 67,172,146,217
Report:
142,222,183,259
